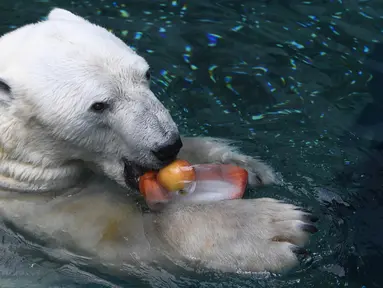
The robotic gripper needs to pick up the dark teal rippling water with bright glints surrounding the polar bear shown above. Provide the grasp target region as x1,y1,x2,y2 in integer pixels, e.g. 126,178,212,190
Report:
0,0,383,288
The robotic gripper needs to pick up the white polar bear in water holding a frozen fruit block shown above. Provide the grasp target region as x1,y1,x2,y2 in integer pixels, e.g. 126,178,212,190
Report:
0,8,317,273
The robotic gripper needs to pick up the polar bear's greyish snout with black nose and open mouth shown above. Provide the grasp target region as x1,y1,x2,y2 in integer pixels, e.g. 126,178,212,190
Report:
115,99,183,188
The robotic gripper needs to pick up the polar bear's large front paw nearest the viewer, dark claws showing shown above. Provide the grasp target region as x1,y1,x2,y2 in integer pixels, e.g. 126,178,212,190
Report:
155,198,317,273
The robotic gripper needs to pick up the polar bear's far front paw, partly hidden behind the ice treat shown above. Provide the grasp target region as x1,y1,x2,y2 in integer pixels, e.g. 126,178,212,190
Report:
179,137,277,186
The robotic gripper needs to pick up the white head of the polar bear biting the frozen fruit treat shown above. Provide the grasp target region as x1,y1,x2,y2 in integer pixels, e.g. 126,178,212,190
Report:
0,9,182,189
